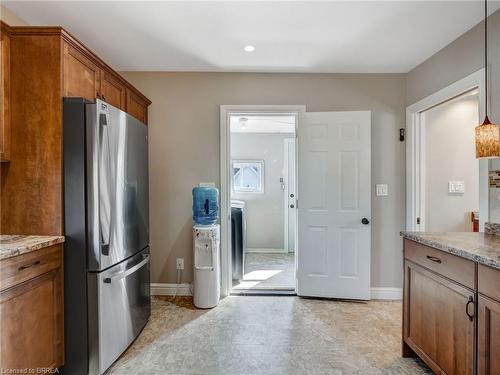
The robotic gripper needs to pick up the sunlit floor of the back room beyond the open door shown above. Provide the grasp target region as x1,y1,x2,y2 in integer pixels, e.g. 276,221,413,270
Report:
233,253,295,290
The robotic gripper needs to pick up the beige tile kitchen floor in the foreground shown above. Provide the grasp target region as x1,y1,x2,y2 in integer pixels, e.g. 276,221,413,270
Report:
109,296,431,375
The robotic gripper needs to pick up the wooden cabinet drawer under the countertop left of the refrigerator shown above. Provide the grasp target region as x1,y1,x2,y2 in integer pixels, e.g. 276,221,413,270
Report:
0,244,62,290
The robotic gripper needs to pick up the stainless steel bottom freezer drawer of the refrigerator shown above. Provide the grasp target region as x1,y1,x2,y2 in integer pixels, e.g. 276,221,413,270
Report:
88,248,151,375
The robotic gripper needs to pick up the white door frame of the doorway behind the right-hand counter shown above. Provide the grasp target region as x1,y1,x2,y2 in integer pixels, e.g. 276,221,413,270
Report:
406,69,489,231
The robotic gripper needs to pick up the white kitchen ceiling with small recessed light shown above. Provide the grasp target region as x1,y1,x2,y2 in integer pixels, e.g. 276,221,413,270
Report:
2,0,500,73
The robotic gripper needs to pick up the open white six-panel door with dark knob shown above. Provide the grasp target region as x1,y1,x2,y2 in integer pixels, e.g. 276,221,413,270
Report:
297,111,371,300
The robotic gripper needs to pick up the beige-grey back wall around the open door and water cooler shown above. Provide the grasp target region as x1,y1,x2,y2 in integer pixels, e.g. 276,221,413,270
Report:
124,72,405,287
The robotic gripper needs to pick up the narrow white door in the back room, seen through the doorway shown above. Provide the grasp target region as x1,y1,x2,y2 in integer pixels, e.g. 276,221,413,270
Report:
283,138,297,252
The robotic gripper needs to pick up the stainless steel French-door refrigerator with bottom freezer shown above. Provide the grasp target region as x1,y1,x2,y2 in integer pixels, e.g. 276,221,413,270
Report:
62,98,150,375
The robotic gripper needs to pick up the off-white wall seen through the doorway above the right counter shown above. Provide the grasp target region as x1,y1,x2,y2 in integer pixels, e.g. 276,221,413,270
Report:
425,95,479,232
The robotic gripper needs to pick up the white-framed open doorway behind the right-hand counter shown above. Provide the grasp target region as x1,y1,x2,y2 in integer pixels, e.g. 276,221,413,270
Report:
406,69,489,232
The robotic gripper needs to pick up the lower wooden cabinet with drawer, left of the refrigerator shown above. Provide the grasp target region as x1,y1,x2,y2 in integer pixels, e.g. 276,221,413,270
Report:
0,245,64,369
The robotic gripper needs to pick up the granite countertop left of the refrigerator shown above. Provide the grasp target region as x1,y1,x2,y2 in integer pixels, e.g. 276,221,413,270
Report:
0,234,64,260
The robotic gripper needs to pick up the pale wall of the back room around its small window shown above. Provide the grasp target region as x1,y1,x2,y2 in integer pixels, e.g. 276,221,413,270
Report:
231,133,293,250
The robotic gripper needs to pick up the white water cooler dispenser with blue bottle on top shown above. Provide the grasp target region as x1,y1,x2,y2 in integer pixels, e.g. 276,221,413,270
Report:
193,187,220,309
